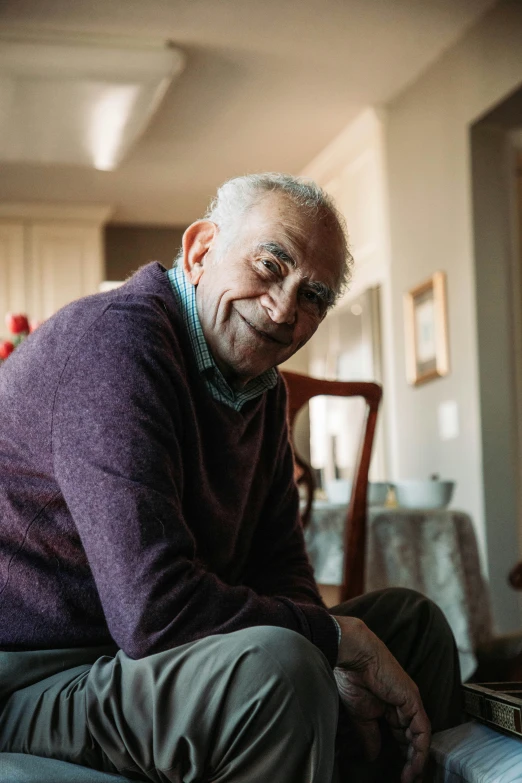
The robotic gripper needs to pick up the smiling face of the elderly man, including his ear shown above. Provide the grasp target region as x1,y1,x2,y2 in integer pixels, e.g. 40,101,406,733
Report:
184,194,343,387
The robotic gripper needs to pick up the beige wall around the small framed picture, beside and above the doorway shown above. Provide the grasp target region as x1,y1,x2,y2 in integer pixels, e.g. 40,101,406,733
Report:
387,2,522,630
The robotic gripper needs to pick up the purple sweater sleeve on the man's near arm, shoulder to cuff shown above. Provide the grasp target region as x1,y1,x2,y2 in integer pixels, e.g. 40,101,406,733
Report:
52,304,337,665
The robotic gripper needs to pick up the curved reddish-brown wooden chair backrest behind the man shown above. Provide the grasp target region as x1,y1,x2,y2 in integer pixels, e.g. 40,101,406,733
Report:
281,371,382,601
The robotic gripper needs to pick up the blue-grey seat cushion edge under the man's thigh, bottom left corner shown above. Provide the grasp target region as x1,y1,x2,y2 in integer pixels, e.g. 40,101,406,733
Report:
0,753,136,783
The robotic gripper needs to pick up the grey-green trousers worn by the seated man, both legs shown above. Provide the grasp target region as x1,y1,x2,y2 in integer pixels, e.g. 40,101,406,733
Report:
0,590,460,783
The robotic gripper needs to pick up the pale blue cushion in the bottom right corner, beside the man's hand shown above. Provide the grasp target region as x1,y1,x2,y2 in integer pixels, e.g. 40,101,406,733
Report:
431,721,522,783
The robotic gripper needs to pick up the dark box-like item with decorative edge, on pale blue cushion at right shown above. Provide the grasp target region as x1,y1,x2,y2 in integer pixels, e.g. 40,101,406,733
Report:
463,682,522,737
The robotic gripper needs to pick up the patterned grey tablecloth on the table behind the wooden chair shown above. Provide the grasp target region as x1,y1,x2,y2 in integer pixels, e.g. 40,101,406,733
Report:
305,502,492,679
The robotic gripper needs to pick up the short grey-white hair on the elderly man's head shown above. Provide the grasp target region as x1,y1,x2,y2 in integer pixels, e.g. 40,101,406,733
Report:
177,172,353,298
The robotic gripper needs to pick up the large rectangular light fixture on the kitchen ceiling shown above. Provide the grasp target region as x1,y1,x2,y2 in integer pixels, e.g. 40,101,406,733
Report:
0,37,185,171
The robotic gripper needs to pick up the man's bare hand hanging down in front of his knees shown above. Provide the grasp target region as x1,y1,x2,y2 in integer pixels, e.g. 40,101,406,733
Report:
334,617,431,783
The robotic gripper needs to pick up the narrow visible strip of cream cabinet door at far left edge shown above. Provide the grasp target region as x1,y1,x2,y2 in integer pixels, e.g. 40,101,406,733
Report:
0,221,27,336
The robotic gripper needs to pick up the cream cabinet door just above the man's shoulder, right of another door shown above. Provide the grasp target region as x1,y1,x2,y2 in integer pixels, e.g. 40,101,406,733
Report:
28,222,103,319
